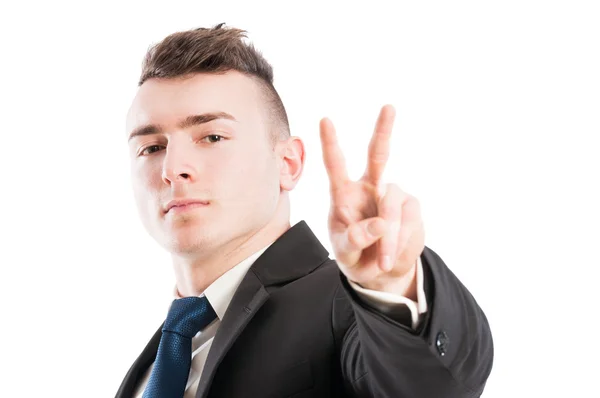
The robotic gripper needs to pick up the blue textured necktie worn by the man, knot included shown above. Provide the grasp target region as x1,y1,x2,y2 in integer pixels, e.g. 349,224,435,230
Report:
143,296,217,398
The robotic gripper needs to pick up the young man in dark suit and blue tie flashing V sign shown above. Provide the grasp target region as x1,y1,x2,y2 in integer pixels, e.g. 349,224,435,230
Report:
117,25,493,398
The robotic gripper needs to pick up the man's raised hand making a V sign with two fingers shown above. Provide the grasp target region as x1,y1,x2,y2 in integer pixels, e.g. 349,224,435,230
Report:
320,105,425,291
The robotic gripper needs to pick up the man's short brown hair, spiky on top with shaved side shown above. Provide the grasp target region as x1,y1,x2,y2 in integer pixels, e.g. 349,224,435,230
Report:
138,23,290,146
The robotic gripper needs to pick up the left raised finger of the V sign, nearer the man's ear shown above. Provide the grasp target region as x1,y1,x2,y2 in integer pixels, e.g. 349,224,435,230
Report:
320,118,348,192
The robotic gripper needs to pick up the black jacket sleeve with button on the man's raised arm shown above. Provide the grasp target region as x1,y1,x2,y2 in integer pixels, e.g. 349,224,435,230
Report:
333,247,494,398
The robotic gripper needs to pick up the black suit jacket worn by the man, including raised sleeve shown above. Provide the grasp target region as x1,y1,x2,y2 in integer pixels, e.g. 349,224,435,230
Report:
116,221,493,398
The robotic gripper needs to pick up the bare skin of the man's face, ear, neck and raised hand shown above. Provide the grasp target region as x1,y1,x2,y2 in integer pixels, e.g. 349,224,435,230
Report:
127,71,424,300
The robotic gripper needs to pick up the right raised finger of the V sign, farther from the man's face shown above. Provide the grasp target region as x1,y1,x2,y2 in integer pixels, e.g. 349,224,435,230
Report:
365,105,396,185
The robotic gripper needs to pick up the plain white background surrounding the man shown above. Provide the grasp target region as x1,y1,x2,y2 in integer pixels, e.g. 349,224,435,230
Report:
0,0,600,398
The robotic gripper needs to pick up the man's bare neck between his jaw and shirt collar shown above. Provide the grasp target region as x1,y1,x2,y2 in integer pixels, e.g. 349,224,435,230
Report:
172,221,290,297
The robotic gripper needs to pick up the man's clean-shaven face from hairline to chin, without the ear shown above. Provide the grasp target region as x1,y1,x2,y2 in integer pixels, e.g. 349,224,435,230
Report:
127,72,280,254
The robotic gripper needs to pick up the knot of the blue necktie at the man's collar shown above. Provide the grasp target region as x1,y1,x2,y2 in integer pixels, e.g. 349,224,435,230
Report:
162,296,217,339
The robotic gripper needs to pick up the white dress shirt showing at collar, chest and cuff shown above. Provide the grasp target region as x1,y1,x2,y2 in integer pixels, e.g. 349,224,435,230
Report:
134,244,427,398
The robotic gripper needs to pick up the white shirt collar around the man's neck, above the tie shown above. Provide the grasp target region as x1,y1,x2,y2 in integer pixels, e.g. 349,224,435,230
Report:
174,243,272,320
